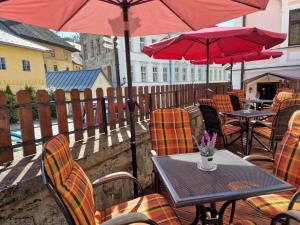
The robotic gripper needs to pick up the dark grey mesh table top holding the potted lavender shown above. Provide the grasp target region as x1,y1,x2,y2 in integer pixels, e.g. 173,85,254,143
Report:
152,150,293,207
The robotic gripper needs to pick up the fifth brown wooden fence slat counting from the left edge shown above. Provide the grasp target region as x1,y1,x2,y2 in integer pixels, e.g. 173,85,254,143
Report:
71,89,83,141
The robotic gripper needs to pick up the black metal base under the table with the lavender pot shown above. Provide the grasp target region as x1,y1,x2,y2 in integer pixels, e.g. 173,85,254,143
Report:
191,201,236,225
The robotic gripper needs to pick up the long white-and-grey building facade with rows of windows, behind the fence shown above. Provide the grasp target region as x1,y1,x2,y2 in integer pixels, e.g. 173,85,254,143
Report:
81,35,228,86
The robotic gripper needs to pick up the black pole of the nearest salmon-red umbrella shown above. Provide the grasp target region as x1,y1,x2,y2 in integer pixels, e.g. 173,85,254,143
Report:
122,1,138,197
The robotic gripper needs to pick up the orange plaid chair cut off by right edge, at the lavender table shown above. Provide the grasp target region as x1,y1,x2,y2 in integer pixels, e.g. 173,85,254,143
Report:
245,110,300,218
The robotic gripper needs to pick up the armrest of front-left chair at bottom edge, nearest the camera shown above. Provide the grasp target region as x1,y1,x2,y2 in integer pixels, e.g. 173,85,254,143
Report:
101,213,157,225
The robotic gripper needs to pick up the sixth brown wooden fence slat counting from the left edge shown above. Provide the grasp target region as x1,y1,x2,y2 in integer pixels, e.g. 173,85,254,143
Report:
84,88,95,137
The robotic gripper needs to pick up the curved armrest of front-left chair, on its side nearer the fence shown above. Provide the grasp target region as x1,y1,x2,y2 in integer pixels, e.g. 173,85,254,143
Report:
93,172,143,196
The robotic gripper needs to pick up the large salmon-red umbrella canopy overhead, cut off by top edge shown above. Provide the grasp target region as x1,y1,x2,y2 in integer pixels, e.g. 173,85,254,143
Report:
0,0,268,36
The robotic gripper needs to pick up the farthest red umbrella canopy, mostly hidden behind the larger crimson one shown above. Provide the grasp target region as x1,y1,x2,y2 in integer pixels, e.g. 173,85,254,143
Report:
191,50,283,65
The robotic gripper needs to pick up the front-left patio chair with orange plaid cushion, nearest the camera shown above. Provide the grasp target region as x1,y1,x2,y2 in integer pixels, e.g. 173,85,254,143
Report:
42,134,181,225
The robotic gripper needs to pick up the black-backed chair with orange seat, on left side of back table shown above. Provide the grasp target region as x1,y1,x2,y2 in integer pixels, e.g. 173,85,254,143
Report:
199,105,244,147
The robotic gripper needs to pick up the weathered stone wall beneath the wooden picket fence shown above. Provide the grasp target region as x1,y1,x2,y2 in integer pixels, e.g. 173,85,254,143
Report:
0,108,203,225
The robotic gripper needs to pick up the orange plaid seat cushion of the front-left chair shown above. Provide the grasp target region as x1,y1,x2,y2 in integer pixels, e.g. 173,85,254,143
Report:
96,194,180,225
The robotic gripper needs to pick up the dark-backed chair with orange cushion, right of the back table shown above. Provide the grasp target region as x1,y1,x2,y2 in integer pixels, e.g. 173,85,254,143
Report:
250,98,300,156
